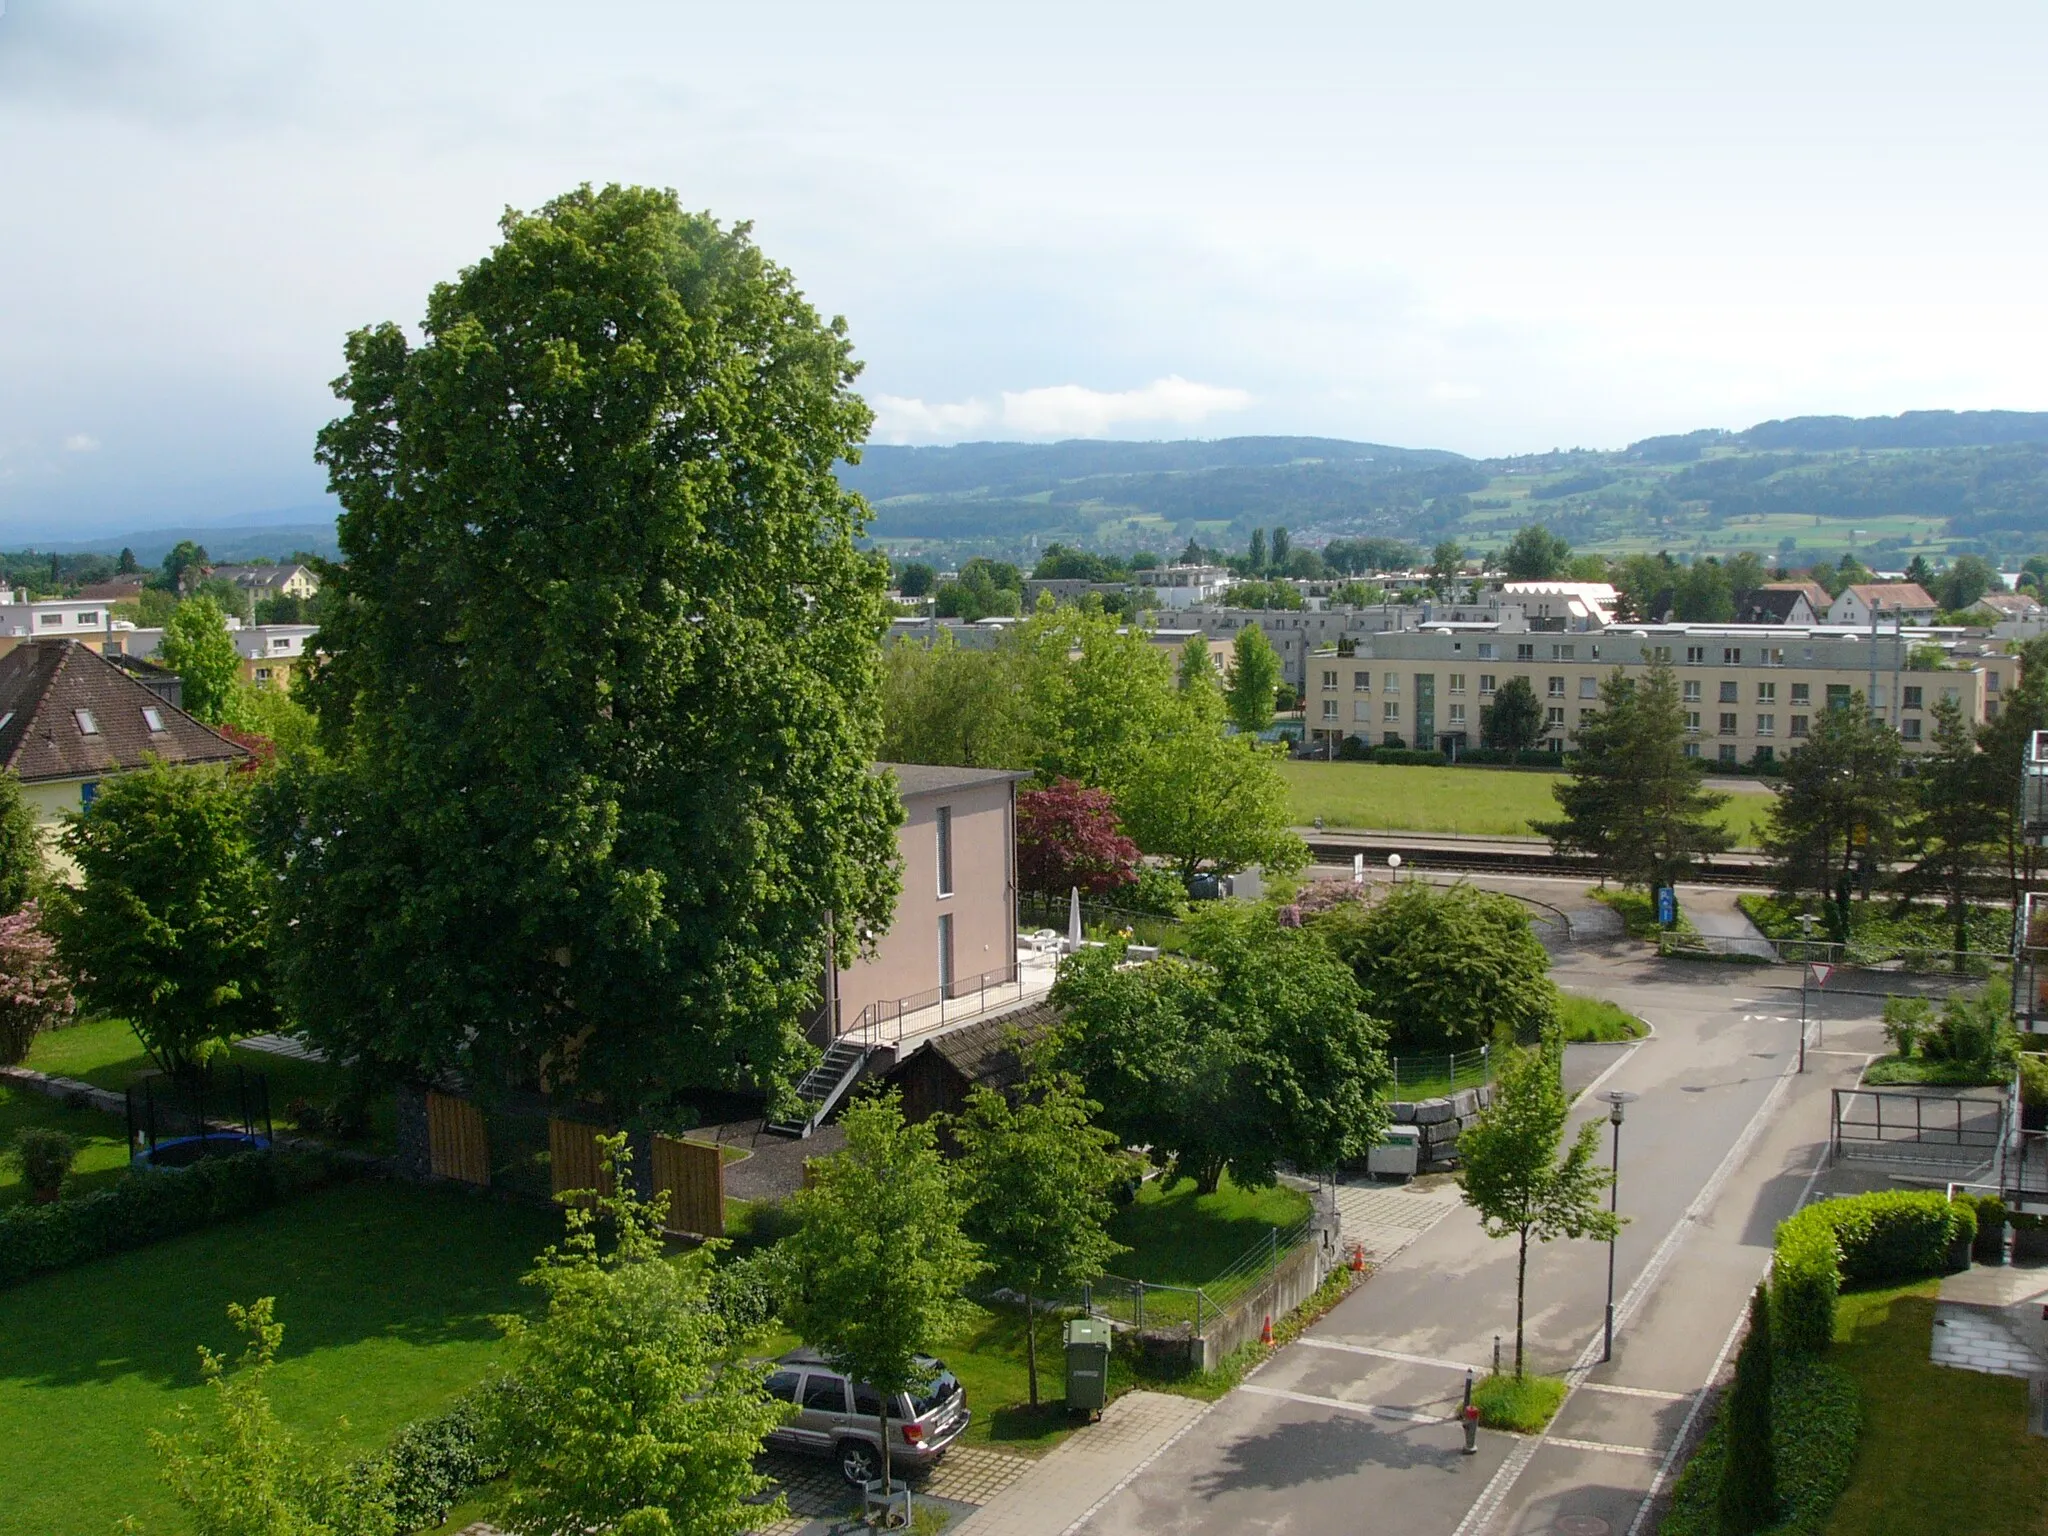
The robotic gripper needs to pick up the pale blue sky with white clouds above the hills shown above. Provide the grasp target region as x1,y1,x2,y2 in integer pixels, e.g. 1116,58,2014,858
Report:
0,0,2048,541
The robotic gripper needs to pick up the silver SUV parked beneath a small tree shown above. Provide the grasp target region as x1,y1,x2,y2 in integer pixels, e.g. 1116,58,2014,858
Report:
768,1350,973,1483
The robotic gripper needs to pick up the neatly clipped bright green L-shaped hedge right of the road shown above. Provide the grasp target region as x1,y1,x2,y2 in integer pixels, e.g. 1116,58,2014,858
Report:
1772,1190,1976,1354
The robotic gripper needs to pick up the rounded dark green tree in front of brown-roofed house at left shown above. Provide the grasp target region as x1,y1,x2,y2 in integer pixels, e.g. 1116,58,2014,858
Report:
47,764,276,1073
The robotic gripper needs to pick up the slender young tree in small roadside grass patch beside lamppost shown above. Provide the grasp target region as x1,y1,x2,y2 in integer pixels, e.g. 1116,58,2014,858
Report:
1458,1030,1620,1376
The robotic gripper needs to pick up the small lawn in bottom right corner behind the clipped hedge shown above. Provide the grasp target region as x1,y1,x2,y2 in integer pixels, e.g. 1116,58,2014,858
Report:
1827,1280,2048,1536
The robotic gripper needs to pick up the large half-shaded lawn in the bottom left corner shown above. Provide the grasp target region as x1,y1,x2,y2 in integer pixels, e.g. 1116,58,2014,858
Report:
0,1182,559,1536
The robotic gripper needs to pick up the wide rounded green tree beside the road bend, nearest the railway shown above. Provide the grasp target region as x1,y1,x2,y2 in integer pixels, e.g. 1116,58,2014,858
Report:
1315,881,1556,1051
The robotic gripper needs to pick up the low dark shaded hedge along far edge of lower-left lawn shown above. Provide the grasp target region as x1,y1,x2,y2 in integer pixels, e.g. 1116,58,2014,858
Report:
0,1151,350,1286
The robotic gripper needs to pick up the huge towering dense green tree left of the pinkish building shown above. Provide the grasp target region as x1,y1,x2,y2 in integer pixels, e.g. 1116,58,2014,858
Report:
266,186,901,1110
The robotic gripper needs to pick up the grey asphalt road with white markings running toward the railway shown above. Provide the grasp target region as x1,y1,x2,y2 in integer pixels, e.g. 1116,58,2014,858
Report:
1083,946,1882,1536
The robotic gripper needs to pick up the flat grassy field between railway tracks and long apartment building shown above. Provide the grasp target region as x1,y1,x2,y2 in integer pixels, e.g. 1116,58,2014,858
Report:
1280,762,1772,848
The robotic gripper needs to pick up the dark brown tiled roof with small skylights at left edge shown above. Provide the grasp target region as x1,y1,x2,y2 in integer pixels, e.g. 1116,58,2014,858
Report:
0,641,250,784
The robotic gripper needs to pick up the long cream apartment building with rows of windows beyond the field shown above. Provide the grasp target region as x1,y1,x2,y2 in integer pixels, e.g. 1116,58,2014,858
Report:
1307,625,2019,766
